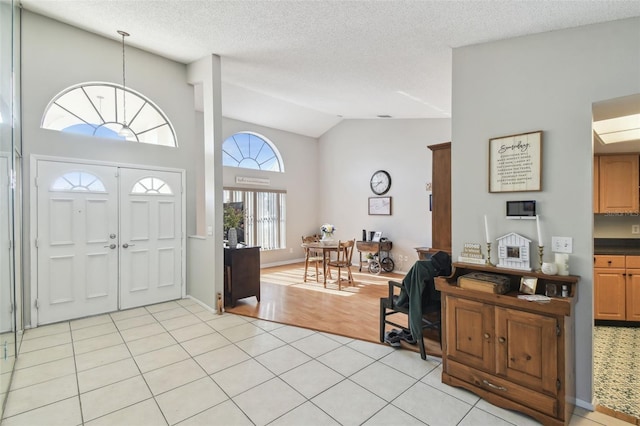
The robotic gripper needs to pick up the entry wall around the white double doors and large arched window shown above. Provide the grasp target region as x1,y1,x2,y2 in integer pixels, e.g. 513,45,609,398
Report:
22,11,202,324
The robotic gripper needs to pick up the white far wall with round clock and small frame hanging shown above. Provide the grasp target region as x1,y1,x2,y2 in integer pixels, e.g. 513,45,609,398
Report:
316,119,451,271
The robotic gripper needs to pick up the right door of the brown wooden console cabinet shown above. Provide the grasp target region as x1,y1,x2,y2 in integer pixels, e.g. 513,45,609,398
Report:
495,308,558,395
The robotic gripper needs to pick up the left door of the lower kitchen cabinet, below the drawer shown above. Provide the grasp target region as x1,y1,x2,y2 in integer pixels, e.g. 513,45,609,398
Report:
593,268,626,321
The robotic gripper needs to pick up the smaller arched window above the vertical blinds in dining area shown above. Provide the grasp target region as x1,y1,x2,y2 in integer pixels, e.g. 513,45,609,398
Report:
222,132,284,172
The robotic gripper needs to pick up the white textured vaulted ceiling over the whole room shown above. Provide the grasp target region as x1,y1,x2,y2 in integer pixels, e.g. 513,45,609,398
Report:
22,0,640,137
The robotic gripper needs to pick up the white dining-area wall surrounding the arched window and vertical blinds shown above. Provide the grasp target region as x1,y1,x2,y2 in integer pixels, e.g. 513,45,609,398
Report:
222,115,320,266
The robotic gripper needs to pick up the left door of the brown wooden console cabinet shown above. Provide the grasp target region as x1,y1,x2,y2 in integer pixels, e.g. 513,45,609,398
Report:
445,297,495,371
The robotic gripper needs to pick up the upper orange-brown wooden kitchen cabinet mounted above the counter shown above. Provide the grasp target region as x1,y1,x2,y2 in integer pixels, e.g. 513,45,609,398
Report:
594,154,640,213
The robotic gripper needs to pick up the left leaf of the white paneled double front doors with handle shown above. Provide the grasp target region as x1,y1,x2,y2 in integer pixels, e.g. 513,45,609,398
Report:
37,160,118,324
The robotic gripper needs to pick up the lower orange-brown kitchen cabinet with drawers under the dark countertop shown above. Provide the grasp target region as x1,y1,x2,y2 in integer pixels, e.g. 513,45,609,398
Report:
593,255,640,321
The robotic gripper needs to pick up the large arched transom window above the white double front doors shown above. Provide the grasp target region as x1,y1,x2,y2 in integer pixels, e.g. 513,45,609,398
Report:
41,83,178,147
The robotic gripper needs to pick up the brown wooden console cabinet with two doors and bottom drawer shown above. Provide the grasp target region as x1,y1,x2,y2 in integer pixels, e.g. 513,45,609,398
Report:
436,263,578,425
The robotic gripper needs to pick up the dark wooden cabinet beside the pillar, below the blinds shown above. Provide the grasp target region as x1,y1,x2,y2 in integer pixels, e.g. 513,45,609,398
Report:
224,247,260,307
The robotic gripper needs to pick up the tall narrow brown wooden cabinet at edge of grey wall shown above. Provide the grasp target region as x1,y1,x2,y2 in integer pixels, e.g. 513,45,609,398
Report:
429,142,451,253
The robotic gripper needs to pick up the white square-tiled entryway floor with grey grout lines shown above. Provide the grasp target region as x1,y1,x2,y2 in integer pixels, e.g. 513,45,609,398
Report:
2,299,628,426
